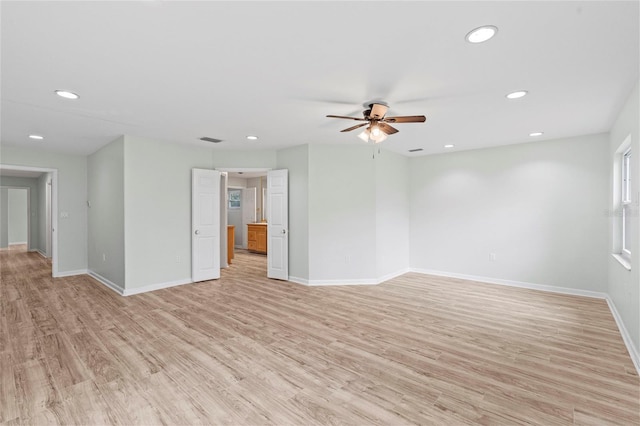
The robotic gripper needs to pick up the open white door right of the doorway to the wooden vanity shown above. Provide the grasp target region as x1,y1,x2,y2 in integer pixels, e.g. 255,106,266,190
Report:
267,170,289,280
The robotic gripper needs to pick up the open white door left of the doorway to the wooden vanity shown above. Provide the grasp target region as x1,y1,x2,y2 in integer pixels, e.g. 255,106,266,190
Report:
191,169,220,282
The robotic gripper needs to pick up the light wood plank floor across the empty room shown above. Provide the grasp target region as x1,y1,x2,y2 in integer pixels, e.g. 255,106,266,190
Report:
0,251,640,425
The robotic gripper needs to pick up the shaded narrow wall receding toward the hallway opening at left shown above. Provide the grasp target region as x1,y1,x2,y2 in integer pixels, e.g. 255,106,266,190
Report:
87,137,126,290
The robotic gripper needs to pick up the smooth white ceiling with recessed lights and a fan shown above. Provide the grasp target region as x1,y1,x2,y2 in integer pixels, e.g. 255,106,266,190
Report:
0,1,640,155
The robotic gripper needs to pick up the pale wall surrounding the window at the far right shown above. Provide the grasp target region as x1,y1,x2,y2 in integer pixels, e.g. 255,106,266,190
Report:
606,79,640,360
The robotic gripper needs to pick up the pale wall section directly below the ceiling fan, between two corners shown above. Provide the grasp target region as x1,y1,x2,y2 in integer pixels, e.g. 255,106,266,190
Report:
308,145,377,284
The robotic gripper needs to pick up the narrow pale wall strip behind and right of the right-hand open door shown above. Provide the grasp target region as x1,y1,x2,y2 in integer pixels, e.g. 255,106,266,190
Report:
277,145,309,282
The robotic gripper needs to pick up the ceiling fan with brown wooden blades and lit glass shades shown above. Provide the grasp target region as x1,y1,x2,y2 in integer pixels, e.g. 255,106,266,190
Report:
327,102,427,143
